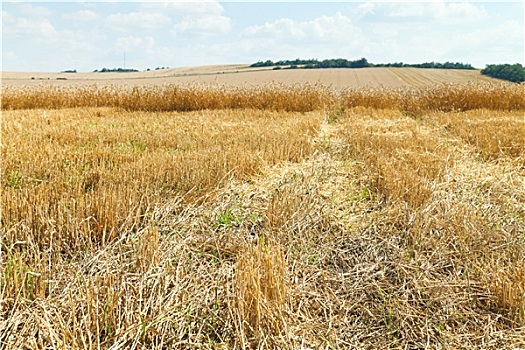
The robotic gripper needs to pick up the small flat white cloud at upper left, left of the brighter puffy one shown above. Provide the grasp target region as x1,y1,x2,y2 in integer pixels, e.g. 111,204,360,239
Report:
106,12,171,31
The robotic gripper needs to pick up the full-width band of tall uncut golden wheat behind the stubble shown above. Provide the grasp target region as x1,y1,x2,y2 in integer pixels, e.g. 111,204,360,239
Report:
2,83,525,115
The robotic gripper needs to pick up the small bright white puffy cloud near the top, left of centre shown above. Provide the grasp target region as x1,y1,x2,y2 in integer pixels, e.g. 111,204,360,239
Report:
171,15,231,35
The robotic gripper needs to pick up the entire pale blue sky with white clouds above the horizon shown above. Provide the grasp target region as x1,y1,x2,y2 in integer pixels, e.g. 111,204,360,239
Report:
1,0,525,72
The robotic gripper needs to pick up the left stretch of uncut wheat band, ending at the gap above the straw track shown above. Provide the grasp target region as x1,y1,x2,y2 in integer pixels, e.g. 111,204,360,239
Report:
2,84,334,112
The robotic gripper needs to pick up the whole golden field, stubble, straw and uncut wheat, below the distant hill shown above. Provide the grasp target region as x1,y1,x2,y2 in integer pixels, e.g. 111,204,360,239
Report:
0,73,525,349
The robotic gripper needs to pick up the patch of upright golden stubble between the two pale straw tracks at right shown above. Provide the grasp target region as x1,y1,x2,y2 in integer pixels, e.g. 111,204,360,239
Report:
344,109,450,208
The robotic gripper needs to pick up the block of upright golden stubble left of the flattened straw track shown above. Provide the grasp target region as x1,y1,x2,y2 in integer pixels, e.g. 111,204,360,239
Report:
1,108,321,250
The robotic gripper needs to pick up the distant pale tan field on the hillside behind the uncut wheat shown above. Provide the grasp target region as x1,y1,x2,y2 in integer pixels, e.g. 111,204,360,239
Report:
2,65,498,90
